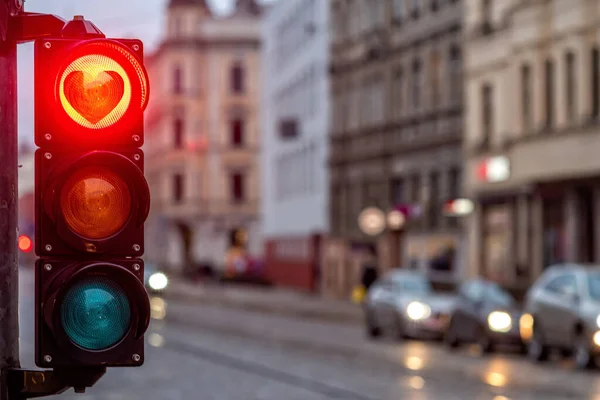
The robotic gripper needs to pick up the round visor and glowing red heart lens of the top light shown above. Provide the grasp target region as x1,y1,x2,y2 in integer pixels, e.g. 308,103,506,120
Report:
57,41,148,130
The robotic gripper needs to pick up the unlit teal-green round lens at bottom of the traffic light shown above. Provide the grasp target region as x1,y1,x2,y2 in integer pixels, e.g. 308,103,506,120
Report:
60,277,131,351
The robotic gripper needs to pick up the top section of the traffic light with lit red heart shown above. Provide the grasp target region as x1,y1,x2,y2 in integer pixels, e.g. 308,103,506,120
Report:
35,39,149,148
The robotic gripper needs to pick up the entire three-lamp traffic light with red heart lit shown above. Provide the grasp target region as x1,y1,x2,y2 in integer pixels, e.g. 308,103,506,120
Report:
34,24,150,368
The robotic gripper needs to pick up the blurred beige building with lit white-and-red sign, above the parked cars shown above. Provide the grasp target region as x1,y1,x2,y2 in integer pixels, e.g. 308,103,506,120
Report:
465,0,600,288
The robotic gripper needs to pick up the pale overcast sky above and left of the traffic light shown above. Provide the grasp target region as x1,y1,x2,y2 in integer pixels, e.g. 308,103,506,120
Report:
18,0,269,143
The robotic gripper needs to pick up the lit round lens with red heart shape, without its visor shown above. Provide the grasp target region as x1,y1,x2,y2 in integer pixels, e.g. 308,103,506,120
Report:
59,54,132,129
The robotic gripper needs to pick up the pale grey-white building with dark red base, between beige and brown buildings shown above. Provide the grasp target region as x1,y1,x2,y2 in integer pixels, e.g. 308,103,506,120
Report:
261,0,329,290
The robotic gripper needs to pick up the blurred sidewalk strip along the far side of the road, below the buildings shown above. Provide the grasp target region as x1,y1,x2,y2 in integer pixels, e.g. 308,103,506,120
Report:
165,279,363,324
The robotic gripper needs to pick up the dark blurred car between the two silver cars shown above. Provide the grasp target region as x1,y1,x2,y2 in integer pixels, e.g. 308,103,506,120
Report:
444,279,524,353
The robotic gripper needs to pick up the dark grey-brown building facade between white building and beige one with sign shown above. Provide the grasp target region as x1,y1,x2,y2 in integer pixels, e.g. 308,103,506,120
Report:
330,0,465,296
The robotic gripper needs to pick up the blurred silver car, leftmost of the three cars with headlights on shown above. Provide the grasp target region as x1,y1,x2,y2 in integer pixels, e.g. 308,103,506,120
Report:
364,269,455,338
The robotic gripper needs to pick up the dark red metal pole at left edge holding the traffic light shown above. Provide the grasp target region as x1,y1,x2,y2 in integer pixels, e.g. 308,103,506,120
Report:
0,10,20,382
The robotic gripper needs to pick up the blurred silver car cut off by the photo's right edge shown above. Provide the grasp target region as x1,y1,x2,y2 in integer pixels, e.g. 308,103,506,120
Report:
522,264,600,368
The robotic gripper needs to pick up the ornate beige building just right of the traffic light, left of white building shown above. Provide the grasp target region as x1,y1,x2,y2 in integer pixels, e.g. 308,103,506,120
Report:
144,0,262,268
